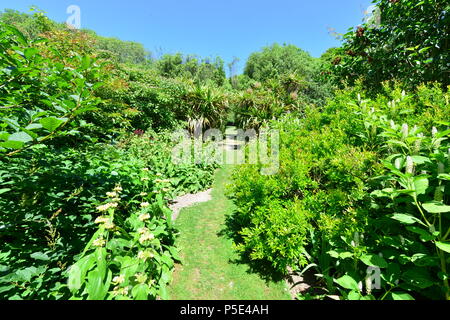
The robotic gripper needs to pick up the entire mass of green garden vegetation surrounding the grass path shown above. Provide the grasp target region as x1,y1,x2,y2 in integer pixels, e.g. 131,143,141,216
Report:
0,0,450,300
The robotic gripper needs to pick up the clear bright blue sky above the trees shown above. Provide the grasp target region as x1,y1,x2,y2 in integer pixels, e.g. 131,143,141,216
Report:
0,0,371,71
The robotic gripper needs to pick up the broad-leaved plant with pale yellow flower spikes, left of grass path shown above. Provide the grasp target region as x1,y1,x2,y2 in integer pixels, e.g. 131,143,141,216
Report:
68,187,178,300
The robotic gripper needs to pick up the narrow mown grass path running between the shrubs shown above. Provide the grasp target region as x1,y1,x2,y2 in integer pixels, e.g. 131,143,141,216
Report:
169,166,290,300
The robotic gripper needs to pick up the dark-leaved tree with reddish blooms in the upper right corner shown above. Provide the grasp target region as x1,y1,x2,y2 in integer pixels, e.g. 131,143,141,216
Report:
334,0,450,89
